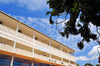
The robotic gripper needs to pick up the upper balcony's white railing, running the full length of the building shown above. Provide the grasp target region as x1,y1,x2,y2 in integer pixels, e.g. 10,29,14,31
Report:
0,24,75,62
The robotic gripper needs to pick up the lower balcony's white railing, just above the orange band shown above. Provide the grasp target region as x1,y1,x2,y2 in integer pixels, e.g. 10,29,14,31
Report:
0,43,68,65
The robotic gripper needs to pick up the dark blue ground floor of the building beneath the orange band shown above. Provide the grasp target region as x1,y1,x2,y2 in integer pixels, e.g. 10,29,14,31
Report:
0,54,55,66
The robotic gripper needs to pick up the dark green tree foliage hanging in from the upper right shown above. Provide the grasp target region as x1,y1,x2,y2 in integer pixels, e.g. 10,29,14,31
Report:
46,0,100,49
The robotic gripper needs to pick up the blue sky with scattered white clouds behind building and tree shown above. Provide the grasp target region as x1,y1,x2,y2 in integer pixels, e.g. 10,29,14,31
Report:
0,0,98,66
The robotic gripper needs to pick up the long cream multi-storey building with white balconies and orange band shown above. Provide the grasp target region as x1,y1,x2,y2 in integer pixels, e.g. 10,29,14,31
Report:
0,11,76,66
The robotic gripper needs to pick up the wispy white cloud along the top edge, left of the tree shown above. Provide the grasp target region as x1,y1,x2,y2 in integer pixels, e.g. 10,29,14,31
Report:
0,0,49,11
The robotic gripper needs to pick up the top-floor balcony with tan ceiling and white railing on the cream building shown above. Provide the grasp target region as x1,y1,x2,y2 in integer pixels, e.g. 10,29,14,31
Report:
0,11,75,63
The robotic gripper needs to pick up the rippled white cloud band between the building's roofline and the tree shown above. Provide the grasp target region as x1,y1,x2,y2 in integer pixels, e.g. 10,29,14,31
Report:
13,16,94,51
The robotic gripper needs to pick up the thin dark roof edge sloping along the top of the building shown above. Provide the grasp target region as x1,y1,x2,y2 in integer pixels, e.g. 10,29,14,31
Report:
0,11,75,52
